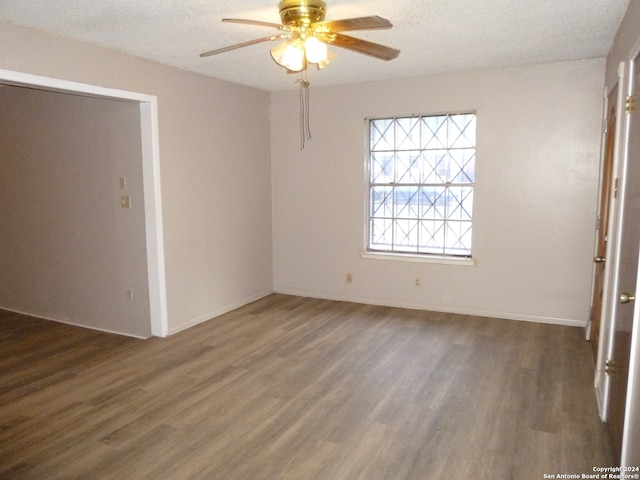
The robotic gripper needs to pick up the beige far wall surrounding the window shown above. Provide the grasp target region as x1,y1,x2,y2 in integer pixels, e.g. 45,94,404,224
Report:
271,59,605,325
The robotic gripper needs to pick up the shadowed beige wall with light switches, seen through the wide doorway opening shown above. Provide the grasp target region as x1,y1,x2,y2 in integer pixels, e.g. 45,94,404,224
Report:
0,87,151,337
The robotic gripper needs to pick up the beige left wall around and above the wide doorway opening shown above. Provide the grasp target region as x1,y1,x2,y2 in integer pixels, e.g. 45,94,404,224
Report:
0,20,272,332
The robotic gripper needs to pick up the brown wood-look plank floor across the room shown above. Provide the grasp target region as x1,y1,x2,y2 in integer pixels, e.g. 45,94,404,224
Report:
0,295,612,480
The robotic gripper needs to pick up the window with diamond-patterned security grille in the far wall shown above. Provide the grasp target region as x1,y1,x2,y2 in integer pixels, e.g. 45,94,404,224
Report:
368,113,476,257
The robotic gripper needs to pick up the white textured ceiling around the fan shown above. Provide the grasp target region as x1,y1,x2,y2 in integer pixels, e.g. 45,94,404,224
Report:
0,0,629,91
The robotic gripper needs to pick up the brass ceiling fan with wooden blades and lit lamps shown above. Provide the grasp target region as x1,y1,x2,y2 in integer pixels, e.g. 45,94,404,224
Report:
200,0,400,72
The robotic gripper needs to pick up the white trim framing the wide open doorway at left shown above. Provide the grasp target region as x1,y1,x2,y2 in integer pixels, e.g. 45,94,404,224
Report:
0,69,169,337
